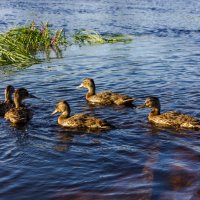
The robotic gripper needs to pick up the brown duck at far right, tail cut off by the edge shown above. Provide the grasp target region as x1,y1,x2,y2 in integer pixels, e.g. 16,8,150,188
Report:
138,97,200,129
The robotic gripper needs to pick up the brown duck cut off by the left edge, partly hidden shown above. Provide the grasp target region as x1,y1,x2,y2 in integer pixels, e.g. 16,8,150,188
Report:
0,85,15,117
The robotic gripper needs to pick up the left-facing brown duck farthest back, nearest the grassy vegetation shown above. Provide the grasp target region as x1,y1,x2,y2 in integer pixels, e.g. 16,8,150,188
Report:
78,78,135,106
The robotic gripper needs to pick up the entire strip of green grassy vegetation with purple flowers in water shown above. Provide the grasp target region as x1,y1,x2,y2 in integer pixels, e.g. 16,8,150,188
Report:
0,21,133,67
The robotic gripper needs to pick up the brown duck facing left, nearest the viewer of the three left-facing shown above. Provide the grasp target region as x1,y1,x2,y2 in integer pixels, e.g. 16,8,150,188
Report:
51,101,111,129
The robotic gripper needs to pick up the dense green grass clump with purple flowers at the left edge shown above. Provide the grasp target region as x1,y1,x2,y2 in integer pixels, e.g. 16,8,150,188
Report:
0,21,67,67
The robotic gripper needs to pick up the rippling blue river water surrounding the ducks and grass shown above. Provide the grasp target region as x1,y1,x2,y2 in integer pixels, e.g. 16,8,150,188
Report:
0,0,200,200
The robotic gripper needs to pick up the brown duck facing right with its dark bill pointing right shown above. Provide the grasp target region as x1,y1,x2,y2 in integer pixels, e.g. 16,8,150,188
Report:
4,88,36,124
